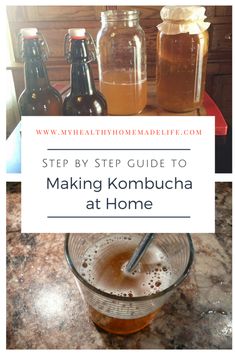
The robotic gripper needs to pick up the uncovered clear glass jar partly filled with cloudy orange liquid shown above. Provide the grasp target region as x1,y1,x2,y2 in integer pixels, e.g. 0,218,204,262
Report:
97,10,147,115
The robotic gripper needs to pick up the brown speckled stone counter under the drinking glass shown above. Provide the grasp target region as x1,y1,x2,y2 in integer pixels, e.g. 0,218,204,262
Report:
7,183,232,349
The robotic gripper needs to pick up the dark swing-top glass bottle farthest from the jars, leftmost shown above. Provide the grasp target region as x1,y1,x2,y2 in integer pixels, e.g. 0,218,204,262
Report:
18,28,62,116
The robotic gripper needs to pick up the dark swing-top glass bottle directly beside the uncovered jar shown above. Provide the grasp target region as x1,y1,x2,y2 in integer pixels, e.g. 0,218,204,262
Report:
63,28,107,115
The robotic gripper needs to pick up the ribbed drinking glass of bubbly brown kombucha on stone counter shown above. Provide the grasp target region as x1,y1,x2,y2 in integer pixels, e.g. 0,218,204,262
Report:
65,234,193,335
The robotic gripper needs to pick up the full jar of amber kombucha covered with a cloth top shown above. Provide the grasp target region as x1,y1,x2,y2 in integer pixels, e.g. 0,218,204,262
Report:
156,6,210,113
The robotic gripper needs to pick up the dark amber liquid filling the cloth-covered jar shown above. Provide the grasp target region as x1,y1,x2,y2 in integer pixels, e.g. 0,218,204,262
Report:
156,31,208,113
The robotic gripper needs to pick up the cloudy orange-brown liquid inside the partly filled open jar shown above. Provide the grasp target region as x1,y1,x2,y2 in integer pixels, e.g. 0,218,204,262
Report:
100,70,147,115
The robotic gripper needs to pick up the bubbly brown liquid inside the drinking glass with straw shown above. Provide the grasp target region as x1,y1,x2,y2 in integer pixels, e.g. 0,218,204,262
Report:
80,235,172,334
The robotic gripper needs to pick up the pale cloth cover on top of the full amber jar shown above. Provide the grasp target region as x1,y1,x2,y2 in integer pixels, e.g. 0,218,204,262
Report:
157,6,210,34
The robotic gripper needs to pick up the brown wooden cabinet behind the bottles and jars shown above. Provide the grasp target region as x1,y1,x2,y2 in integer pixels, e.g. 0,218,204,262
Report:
7,6,232,123
